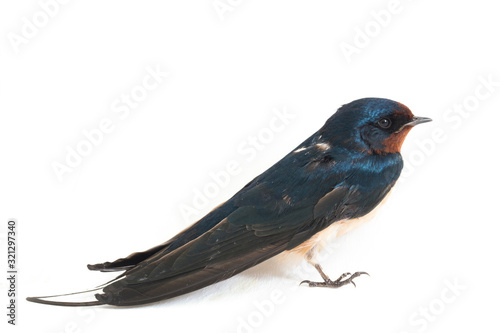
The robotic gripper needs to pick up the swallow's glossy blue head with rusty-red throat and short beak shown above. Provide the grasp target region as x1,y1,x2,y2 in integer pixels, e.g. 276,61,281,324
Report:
321,98,431,155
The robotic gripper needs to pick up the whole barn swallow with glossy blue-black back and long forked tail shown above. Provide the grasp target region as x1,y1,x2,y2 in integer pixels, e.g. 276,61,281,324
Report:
27,98,431,306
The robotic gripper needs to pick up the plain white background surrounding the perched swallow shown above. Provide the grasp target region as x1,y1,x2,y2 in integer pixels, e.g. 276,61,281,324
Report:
0,0,500,333
